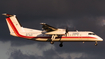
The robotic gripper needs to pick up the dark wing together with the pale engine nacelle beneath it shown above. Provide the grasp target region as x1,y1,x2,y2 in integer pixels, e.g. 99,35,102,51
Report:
40,23,66,35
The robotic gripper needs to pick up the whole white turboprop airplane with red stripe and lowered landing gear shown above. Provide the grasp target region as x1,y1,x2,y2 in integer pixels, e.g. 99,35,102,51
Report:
3,13,103,47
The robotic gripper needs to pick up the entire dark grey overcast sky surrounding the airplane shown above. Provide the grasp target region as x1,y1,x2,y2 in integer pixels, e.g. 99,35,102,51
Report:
0,0,105,59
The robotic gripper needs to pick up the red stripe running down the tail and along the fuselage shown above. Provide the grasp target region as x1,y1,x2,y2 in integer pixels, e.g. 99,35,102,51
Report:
6,18,96,39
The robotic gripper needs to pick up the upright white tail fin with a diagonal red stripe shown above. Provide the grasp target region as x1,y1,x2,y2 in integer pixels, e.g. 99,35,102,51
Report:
3,14,22,36
